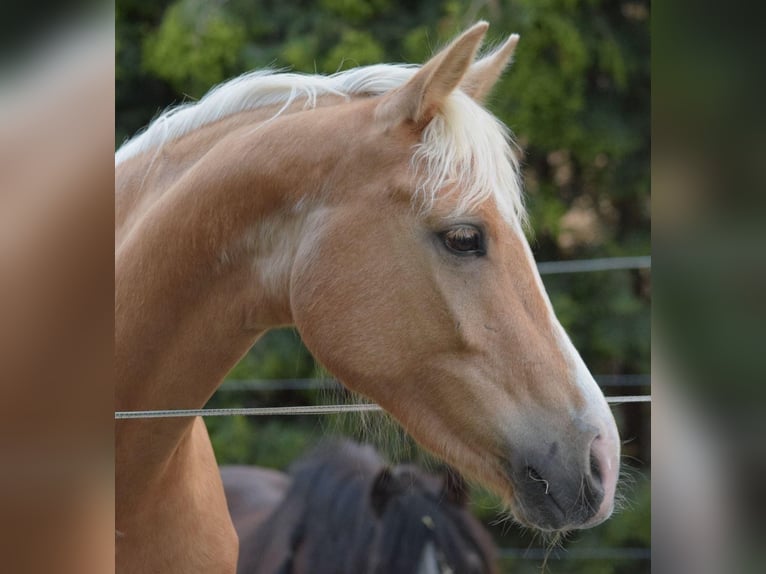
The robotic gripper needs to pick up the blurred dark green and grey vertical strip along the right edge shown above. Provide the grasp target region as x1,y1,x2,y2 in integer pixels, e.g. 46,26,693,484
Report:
652,2,766,574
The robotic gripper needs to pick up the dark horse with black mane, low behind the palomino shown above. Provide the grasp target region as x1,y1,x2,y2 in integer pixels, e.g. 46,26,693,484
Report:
221,441,497,574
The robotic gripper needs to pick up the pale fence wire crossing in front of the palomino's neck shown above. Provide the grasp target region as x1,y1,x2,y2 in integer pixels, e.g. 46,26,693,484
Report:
114,395,652,419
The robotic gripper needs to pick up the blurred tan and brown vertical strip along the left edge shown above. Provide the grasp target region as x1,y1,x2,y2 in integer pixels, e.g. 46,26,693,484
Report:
0,7,114,574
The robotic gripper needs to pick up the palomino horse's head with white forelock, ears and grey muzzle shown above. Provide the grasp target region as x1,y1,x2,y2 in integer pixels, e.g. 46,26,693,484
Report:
289,23,620,531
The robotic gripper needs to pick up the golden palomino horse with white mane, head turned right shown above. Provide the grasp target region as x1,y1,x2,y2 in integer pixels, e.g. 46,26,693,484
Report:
115,22,619,574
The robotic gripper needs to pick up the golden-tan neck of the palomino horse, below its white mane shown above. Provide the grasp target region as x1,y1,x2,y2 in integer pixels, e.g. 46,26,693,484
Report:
115,103,358,482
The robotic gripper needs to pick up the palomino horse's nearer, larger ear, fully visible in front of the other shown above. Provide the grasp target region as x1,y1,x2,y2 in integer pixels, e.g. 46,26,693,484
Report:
375,22,489,125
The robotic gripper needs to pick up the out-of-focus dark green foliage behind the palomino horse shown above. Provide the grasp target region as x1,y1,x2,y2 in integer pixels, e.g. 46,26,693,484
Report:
116,0,651,574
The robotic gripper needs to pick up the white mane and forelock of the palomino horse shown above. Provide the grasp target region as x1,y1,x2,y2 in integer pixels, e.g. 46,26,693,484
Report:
115,64,526,227
